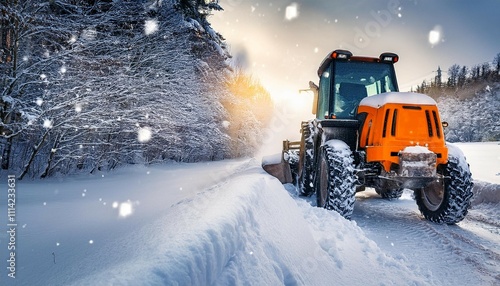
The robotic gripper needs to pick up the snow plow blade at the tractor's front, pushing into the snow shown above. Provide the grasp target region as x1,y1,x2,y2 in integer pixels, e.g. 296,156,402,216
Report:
262,140,300,184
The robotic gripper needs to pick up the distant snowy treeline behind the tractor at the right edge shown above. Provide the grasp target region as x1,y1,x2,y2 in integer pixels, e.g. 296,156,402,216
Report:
415,53,500,142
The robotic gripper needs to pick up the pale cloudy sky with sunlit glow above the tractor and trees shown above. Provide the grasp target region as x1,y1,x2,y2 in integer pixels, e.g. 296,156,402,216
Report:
209,0,500,98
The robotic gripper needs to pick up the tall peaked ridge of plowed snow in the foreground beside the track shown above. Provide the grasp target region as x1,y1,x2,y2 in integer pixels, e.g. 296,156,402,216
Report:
76,166,429,285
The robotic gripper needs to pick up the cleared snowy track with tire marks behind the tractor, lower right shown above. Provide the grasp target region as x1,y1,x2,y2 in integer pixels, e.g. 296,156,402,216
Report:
353,191,500,285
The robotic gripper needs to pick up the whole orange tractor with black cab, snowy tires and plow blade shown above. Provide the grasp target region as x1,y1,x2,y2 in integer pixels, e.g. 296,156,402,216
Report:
263,50,473,224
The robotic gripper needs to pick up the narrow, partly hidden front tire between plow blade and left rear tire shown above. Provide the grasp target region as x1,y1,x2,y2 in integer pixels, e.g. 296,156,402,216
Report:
298,122,314,196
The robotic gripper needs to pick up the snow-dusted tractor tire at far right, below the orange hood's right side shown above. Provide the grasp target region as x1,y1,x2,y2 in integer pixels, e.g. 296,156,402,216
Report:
415,146,473,224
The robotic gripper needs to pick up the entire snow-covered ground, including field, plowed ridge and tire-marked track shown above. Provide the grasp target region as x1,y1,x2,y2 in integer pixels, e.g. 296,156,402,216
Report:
0,142,500,285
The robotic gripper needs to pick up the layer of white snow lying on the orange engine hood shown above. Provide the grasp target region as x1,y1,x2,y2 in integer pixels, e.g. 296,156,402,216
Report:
359,92,436,108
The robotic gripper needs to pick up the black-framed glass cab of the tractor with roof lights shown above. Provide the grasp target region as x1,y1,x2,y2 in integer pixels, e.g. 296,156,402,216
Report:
313,50,398,120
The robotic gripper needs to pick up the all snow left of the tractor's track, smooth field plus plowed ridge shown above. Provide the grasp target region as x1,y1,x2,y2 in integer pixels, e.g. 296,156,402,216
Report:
0,160,454,285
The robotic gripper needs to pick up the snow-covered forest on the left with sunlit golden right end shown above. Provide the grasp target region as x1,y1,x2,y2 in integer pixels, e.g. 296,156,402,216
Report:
0,0,272,178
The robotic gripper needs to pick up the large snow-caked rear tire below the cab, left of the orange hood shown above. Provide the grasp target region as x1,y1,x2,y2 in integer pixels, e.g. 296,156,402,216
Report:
316,140,356,219
